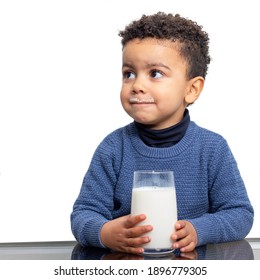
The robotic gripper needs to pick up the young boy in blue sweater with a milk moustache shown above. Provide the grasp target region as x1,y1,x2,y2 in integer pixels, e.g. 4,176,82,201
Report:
71,12,253,254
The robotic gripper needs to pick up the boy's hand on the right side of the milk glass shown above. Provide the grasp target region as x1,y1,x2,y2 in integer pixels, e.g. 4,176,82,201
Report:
171,220,198,253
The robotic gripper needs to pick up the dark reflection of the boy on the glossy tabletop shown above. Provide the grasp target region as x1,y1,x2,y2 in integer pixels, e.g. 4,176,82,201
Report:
71,240,254,260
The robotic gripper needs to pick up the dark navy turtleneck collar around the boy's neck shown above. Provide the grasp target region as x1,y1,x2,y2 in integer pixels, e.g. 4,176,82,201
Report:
135,109,190,148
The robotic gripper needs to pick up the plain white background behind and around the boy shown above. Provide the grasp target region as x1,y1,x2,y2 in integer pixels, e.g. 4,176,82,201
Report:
0,0,260,242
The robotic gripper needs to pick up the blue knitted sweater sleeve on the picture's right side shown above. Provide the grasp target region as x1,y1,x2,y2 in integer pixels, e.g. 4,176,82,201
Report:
190,139,254,245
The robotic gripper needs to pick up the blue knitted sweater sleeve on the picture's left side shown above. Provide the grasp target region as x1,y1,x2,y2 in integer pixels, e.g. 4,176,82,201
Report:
71,137,116,247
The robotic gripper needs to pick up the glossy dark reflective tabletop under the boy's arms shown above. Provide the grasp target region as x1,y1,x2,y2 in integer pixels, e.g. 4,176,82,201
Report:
0,239,260,260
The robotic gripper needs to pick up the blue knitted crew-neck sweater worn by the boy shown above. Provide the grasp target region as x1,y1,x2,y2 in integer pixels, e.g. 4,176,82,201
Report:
71,121,254,247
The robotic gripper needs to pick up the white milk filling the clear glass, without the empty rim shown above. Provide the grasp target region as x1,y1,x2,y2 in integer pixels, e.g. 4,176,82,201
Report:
131,187,177,251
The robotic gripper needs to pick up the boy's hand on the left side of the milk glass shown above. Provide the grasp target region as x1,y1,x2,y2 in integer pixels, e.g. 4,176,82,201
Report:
100,214,153,254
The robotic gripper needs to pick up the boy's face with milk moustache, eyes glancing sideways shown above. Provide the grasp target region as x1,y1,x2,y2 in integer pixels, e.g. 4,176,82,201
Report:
121,38,199,129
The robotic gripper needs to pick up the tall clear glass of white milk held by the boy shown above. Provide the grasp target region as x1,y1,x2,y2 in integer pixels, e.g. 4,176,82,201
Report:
131,170,177,254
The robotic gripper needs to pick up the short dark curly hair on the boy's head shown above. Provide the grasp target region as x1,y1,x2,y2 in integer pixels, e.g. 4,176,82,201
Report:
118,12,210,79
